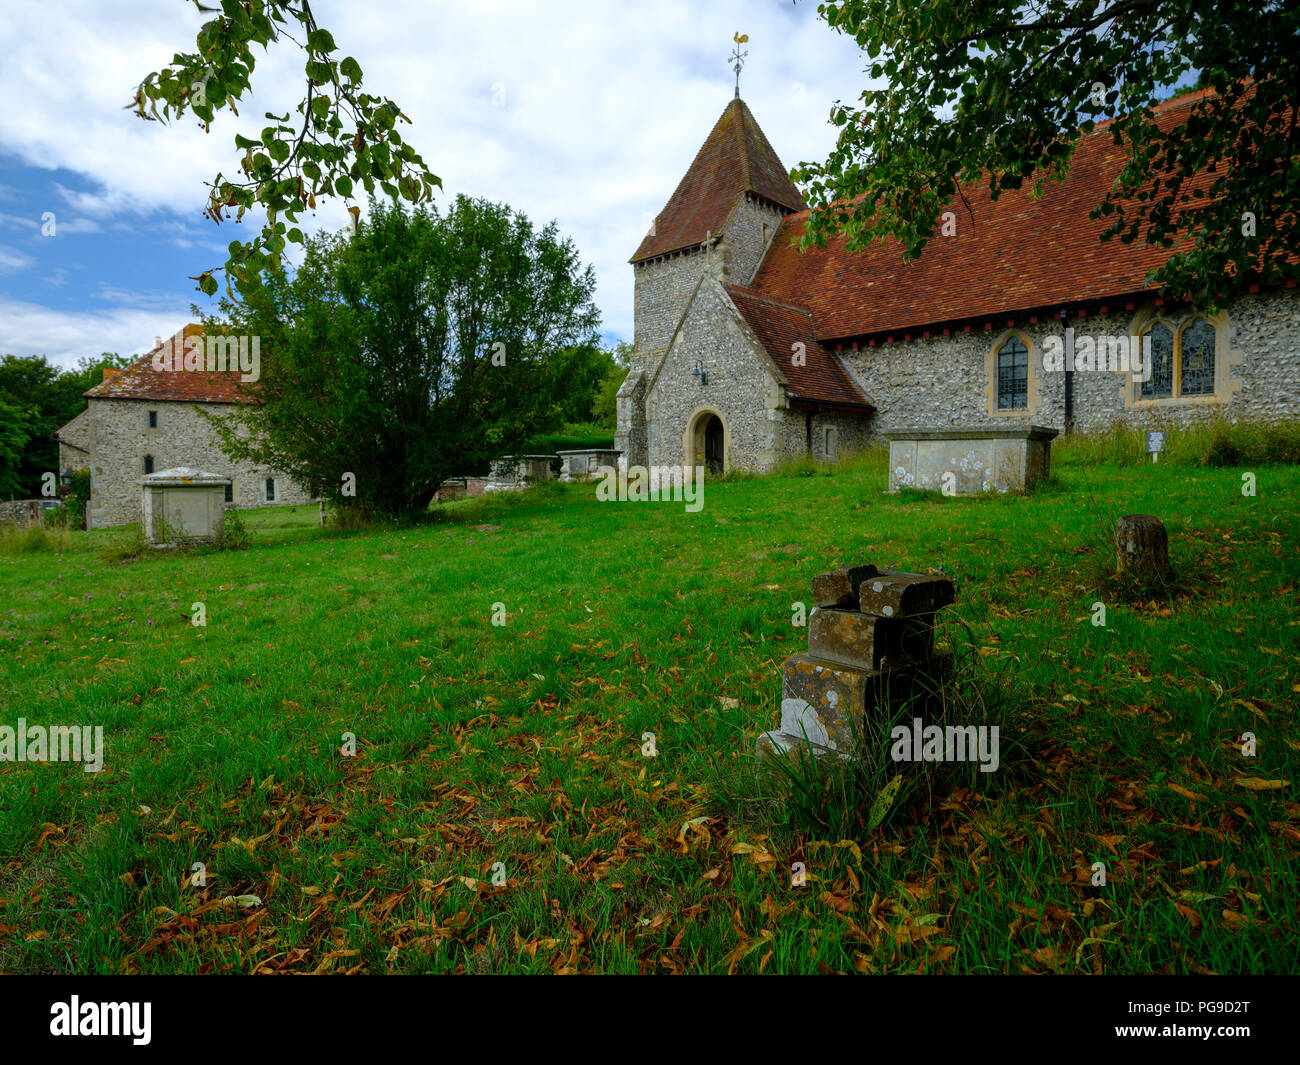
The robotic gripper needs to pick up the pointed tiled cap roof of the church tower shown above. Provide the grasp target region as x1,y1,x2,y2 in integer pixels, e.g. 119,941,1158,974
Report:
629,96,806,263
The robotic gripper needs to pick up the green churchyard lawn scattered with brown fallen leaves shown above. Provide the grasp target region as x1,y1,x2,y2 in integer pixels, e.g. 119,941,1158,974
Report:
0,455,1300,973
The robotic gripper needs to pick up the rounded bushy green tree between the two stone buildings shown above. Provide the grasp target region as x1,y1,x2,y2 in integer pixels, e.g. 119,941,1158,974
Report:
209,196,599,518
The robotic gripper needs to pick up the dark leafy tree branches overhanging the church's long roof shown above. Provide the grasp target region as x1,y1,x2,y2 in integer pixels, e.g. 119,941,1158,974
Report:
794,0,1300,307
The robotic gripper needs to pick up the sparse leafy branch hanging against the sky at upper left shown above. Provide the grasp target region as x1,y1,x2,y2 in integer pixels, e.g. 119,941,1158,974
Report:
127,0,442,296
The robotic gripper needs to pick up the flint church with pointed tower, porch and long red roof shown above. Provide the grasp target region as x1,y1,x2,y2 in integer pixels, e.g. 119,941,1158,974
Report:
615,94,1300,469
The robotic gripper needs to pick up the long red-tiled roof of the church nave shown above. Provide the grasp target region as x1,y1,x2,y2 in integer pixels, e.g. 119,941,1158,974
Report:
750,92,1227,339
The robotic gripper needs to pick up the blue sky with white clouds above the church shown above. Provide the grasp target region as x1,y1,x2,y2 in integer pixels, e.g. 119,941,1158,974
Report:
0,0,866,365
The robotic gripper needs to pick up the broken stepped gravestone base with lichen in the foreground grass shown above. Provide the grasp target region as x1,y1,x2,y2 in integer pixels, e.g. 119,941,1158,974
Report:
758,566,956,758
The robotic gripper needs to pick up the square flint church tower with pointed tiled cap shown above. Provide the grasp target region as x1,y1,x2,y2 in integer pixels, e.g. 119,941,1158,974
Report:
615,98,806,464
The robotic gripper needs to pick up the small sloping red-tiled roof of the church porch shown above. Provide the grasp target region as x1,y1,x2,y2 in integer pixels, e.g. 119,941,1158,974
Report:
727,285,874,411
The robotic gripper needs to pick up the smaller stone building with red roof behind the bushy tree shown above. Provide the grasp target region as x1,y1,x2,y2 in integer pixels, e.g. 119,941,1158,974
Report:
56,325,312,529
